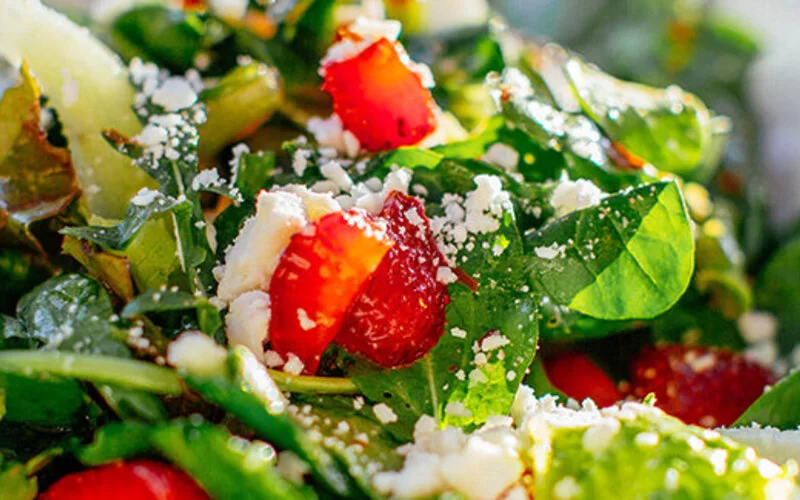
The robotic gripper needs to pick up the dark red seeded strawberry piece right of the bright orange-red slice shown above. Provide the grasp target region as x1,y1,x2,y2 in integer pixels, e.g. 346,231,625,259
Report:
336,191,449,368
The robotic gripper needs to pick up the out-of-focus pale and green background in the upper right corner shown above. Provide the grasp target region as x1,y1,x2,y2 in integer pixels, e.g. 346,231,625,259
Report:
504,0,800,233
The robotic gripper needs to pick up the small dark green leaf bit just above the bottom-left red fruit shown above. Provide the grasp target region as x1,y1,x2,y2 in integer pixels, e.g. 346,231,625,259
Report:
75,421,153,467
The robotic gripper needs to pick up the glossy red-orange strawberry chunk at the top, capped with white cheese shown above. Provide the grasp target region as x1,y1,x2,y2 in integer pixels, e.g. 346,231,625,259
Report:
322,38,436,151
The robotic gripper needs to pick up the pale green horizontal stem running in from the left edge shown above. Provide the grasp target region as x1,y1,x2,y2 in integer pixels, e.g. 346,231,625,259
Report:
0,350,182,395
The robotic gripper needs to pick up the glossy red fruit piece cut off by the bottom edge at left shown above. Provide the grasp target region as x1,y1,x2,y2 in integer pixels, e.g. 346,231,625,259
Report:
39,460,211,500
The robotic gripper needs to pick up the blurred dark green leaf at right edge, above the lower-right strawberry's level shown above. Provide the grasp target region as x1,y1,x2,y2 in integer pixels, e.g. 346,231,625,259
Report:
755,238,800,352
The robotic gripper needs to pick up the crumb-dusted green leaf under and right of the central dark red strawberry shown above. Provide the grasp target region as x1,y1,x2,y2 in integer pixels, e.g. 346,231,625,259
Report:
351,186,538,440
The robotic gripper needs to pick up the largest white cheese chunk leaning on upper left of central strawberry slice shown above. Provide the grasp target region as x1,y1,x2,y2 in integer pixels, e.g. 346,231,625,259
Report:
217,192,306,302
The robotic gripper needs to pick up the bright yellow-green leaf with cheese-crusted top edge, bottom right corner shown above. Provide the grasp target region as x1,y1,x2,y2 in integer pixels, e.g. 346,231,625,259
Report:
526,403,796,500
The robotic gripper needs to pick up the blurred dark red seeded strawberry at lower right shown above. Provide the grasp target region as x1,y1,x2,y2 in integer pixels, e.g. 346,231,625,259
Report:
630,344,775,427
